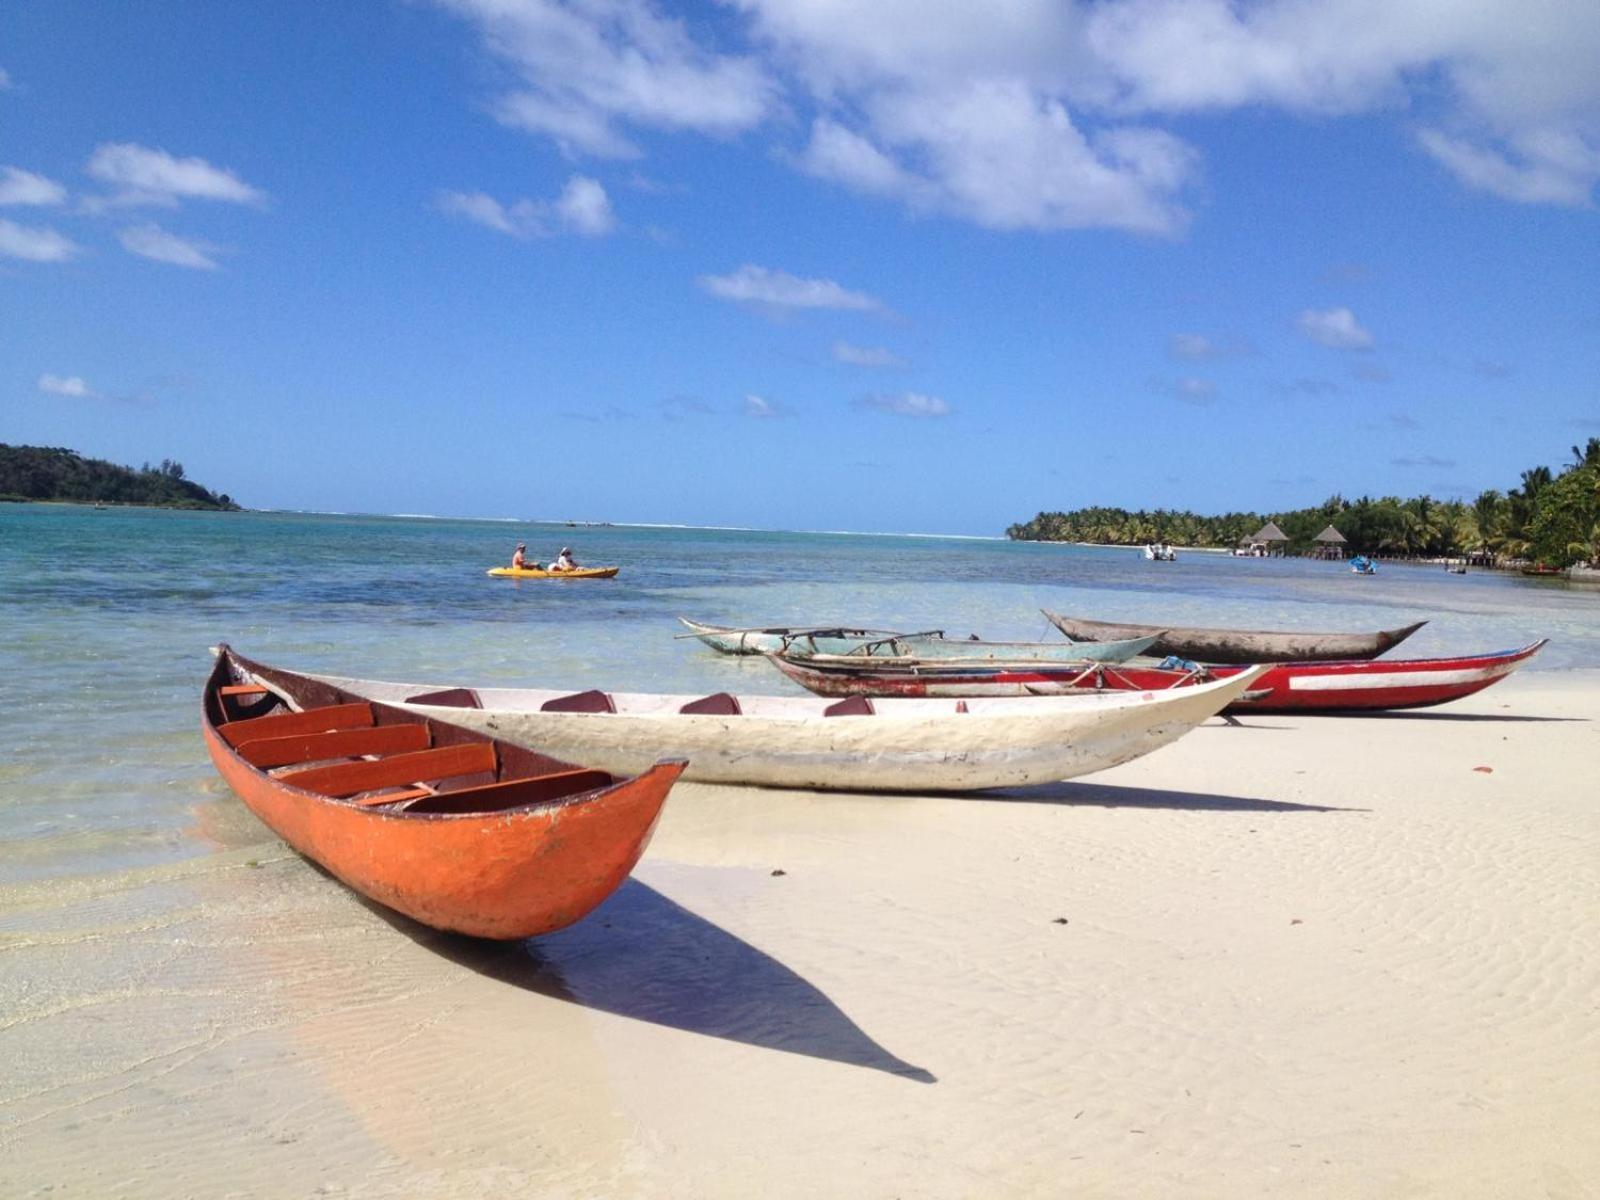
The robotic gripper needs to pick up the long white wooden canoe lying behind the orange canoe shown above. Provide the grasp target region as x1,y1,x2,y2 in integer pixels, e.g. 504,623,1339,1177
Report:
300,672,1253,792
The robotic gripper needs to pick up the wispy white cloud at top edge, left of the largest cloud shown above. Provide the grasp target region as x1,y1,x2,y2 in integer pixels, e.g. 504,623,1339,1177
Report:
438,0,776,158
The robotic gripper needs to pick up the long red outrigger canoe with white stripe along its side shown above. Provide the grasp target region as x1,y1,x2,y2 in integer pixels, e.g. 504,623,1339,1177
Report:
770,640,1544,712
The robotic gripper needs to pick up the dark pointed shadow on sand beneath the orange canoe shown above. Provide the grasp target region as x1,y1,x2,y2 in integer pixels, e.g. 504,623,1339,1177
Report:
368,878,938,1083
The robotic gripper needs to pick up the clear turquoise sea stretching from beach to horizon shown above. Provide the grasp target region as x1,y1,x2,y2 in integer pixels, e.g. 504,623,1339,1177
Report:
9,504,1600,888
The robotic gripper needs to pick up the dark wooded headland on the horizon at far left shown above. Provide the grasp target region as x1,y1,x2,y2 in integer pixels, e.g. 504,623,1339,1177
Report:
0,442,238,512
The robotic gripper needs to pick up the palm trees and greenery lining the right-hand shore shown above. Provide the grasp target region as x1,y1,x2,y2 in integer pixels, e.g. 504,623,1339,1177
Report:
1006,437,1600,566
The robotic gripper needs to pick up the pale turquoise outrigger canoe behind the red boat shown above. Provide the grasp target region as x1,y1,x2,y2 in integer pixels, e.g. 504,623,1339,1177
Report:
678,616,1155,662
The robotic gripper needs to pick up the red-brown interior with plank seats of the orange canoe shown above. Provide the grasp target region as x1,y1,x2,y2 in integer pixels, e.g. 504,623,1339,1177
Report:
205,648,618,818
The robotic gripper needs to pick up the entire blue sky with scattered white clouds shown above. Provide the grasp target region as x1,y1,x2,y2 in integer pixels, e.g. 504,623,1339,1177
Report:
0,0,1600,533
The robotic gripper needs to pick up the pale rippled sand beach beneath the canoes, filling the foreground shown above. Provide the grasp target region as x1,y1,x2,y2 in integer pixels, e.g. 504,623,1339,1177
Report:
0,672,1600,1198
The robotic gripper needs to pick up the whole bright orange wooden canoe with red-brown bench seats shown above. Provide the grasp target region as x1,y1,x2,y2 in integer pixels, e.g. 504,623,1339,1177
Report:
202,646,683,938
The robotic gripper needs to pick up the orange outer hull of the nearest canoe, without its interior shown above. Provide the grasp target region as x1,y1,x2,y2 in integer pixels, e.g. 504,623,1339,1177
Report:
202,654,683,939
